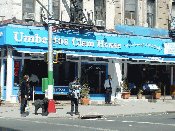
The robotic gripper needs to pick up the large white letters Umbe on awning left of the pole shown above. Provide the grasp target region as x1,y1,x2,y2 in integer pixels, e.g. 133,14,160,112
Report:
13,32,48,44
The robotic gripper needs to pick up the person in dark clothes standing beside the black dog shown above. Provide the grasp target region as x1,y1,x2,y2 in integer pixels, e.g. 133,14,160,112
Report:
20,75,29,116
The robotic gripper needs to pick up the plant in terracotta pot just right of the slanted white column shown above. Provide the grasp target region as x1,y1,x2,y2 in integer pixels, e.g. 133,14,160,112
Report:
121,78,131,99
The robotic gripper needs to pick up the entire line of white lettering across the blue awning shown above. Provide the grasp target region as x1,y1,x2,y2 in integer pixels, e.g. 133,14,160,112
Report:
12,32,163,51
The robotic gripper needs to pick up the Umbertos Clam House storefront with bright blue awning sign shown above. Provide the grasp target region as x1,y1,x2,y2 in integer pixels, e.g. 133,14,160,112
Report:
0,24,175,101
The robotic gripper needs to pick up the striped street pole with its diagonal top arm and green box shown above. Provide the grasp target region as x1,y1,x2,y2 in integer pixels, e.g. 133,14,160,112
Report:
36,0,56,113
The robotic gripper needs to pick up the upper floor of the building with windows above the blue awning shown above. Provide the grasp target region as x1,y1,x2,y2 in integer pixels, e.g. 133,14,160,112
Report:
0,0,175,30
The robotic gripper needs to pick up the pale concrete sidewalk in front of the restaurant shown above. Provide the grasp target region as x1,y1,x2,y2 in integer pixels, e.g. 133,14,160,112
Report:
0,99,175,118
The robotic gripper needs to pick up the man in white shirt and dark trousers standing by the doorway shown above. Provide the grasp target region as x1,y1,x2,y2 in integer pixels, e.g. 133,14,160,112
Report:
104,75,112,104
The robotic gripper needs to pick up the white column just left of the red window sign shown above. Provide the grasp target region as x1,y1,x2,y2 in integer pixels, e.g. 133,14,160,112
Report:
6,48,13,101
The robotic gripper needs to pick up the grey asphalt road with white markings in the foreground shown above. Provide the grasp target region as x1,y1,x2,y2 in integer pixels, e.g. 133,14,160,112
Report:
0,113,175,131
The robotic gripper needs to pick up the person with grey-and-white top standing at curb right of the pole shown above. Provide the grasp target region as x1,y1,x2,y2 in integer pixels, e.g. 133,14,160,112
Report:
69,77,82,116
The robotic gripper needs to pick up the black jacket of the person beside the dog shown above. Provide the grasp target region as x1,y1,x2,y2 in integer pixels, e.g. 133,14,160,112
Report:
20,80,29,98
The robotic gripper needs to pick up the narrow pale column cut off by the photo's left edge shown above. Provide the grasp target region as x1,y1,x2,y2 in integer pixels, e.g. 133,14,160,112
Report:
1,49,5,100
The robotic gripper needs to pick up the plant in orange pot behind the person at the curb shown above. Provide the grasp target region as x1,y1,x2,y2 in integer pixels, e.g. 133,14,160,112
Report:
80,76,90,105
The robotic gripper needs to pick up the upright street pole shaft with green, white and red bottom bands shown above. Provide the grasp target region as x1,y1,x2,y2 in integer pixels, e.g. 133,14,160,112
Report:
48,0,56,113
